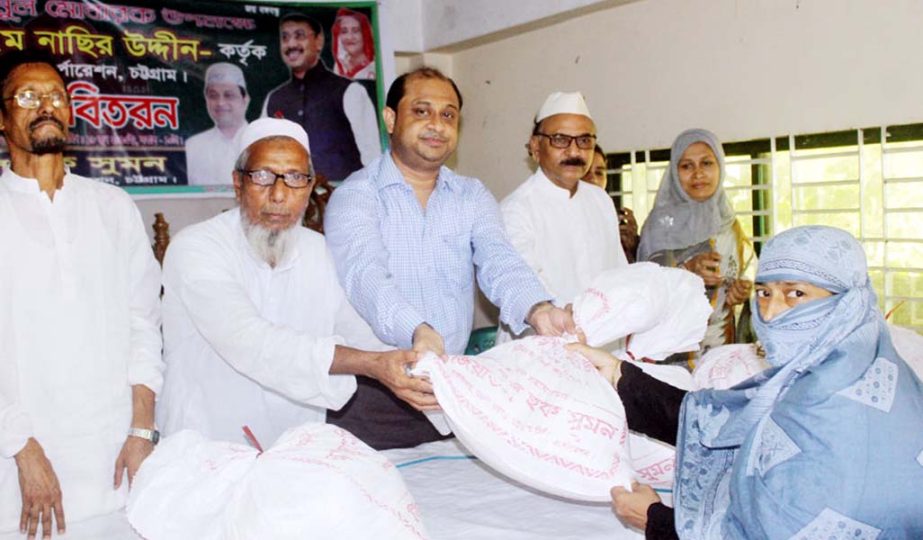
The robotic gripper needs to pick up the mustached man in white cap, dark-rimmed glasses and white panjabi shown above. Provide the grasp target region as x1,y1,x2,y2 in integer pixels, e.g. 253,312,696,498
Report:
498,92,628,342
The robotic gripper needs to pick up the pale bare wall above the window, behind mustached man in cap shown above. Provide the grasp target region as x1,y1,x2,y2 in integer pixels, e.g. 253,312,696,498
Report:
451,0,923,198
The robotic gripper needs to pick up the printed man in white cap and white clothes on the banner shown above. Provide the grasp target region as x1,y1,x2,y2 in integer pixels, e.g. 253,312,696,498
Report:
186,62,250,186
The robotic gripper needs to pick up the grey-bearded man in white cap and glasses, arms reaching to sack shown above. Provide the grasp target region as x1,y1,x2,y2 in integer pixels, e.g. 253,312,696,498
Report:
157,118,436,446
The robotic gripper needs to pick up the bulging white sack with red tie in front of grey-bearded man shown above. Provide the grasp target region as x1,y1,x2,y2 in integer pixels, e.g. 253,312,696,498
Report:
127,423,427,540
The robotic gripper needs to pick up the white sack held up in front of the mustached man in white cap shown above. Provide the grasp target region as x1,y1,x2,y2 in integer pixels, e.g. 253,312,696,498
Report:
574,262,712,360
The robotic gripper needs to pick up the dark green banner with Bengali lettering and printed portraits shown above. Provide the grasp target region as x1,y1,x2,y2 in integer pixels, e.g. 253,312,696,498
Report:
0,0,383,196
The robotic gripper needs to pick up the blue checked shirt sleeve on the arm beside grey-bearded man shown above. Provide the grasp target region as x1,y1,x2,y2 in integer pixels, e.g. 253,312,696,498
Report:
324,182,425,349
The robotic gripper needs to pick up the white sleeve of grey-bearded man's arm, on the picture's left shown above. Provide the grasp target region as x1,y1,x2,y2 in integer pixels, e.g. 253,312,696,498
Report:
164,238,356,409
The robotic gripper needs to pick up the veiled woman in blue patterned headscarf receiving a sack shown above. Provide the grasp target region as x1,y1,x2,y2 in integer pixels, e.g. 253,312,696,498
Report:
576,226,923,540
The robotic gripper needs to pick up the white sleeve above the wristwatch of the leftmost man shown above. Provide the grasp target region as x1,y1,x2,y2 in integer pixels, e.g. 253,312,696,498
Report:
126,204,164,394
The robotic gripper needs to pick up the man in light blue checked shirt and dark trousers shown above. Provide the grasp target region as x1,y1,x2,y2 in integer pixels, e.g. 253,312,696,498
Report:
324,68,574,449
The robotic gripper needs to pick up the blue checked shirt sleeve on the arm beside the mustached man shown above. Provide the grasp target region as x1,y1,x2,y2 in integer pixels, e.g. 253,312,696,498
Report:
471,182,551,334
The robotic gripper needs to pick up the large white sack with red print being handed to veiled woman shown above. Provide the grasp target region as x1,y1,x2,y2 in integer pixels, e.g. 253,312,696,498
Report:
415,336,632,502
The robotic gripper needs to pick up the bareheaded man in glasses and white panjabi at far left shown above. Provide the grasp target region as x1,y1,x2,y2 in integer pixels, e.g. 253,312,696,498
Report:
0,51,163,539
